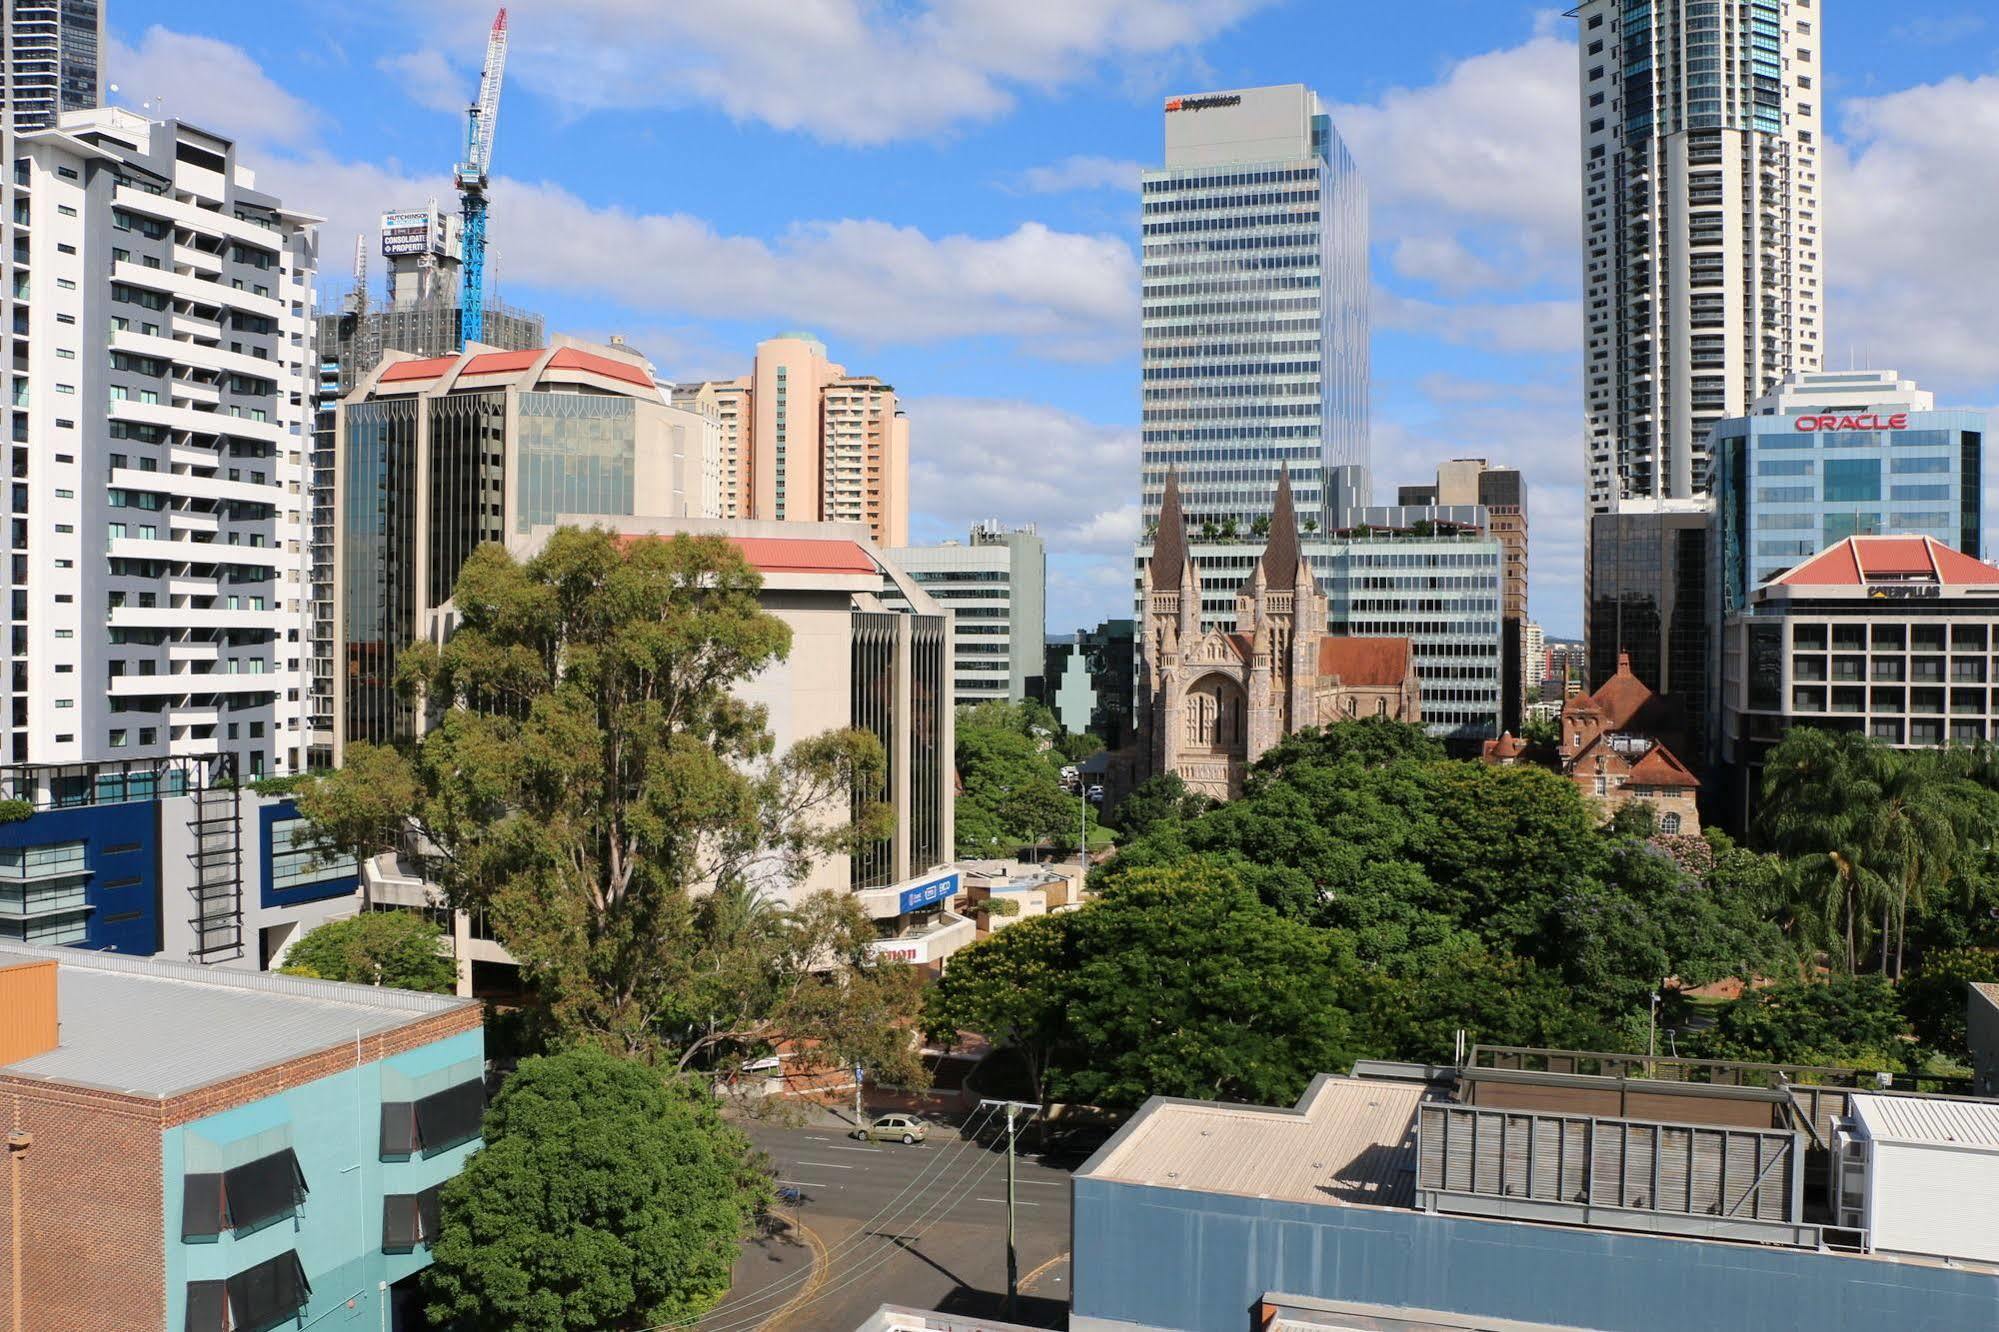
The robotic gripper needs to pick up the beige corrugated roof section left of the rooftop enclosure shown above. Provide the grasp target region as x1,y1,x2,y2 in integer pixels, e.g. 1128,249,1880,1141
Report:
1087,1076,1433,1206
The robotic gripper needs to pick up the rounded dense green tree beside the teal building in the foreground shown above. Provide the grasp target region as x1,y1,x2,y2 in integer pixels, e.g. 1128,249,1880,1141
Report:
422,1048,770,1332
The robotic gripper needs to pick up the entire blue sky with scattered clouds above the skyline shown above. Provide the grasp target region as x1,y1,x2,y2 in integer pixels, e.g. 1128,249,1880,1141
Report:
110,0,1999,634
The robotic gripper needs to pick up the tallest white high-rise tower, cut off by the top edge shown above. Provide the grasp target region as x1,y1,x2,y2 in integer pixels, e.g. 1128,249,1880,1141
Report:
1575,0,1825,512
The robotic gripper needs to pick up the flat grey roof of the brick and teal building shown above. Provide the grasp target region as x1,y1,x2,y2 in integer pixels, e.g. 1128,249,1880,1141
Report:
0,944,478,1098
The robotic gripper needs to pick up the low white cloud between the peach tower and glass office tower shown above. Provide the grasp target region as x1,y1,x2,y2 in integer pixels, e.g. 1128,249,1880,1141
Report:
906,398,1139,560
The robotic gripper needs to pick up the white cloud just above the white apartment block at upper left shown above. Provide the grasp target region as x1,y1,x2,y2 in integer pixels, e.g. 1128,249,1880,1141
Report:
104,24,320,148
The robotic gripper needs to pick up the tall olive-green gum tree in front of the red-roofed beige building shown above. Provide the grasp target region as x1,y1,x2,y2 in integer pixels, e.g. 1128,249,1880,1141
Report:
298,528,914,1058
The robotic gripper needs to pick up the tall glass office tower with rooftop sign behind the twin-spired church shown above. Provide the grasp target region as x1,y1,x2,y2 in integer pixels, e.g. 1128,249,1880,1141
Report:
1135,84,1369,626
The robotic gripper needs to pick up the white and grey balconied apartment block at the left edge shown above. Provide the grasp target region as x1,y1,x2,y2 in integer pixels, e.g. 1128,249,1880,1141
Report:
0,114,316,778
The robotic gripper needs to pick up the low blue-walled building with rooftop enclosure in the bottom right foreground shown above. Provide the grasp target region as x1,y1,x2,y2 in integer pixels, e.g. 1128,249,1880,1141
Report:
1069,1046,1999,1332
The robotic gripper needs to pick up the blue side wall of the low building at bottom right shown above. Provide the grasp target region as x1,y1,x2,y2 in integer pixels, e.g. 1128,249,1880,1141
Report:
1069,1178,1999,1332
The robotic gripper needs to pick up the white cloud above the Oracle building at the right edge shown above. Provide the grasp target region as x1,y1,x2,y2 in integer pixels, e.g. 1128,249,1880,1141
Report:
1825,74,1999,400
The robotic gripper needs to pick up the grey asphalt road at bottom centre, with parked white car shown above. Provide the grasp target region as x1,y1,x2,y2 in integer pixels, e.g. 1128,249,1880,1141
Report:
702,1124,1069,1332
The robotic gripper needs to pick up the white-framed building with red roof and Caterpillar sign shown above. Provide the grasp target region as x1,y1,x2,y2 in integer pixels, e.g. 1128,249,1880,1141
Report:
1715,536,1999,820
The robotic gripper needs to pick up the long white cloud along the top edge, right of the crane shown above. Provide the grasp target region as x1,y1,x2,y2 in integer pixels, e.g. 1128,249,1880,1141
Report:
396,0,1269,144
